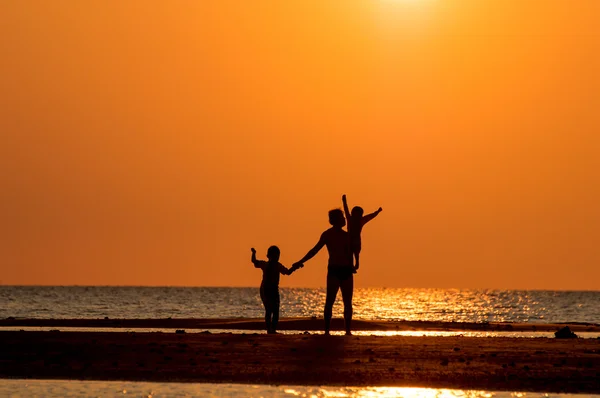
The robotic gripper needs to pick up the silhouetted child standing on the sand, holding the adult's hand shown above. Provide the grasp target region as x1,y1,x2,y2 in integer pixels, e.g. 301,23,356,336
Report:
250,246,303,334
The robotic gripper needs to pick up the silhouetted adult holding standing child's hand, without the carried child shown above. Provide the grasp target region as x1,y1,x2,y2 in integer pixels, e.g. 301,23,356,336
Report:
294,209,354,335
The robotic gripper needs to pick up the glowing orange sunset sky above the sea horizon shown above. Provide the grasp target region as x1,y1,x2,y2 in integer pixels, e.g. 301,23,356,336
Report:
0,0,600,290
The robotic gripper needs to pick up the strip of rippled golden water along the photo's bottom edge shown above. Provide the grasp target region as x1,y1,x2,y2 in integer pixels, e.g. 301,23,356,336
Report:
0,380,598,398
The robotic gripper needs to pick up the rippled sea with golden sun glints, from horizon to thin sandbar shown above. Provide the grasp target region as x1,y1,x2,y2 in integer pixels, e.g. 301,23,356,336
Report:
0,286,600,324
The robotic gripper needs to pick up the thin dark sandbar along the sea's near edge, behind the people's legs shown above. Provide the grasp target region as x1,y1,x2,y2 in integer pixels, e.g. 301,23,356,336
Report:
0,318,600,333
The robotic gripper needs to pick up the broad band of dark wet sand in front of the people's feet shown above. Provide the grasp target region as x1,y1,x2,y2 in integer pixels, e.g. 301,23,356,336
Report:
0,325,600,394
